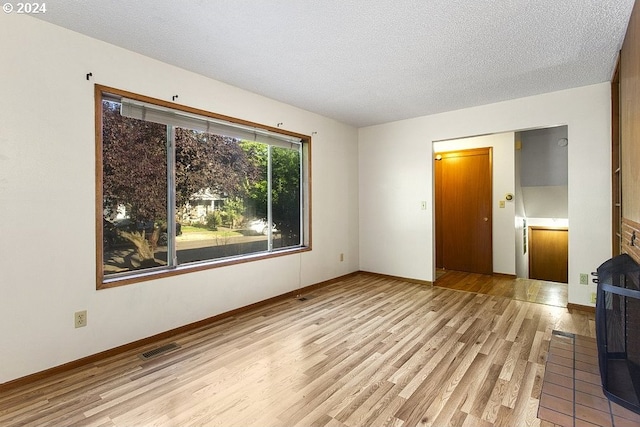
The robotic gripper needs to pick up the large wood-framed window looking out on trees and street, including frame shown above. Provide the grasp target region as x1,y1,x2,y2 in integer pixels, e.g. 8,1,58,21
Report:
96,86,309,287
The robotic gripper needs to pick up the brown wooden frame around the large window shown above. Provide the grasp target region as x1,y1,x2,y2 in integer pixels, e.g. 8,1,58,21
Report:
94,84,312,289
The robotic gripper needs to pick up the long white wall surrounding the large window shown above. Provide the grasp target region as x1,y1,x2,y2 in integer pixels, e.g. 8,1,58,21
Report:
0,14,359,383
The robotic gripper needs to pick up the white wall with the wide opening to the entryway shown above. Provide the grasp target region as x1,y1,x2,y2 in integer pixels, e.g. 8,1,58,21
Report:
359,83,611,305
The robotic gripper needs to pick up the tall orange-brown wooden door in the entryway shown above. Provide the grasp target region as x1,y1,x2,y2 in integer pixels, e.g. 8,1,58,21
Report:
435,148,493,274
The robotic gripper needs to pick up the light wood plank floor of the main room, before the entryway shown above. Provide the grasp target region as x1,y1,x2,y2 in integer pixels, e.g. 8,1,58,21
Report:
0,273,594,427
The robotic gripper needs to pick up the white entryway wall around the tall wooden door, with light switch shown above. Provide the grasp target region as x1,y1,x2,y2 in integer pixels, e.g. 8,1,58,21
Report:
433,132,516,275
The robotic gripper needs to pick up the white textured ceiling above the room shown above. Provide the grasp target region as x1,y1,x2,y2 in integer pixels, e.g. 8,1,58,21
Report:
39,0,634,127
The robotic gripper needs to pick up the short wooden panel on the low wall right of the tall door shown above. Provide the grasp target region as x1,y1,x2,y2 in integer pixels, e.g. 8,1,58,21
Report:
529,227,569,283
